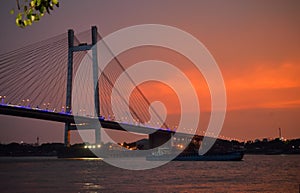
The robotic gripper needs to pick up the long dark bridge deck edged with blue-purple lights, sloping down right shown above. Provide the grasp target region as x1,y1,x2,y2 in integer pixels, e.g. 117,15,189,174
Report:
0,104,188,147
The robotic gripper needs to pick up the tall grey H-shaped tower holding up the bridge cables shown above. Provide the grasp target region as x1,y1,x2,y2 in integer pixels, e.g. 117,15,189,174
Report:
64,26,100,146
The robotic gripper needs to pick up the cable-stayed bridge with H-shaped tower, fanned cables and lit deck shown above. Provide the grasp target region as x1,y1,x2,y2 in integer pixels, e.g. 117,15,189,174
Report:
0,26,220,147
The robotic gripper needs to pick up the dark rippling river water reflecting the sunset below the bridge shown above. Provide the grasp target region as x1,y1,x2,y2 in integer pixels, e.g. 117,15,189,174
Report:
0,155,300,193
